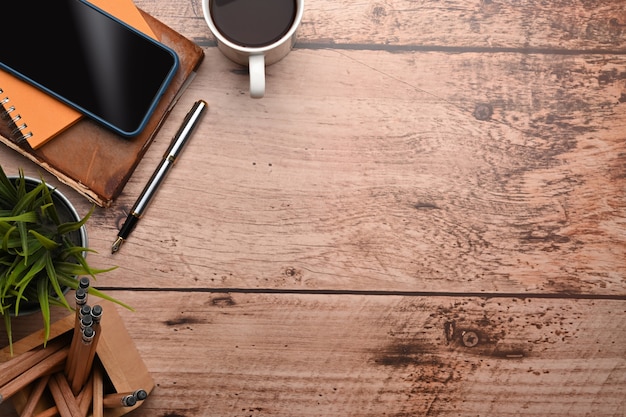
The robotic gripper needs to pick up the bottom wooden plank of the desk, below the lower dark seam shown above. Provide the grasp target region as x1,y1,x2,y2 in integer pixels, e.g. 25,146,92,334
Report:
4,291,626,417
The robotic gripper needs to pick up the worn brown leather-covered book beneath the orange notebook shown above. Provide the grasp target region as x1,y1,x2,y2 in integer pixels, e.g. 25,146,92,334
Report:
0,11,204,207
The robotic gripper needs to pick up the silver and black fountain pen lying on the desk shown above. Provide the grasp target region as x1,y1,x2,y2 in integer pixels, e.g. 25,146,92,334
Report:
111,100,209,253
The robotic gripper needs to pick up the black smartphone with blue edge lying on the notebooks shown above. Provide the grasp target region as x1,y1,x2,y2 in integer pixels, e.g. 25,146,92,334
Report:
0,0,179,137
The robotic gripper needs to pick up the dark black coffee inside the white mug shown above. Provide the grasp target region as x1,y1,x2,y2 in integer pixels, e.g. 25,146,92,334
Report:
209,0,297,48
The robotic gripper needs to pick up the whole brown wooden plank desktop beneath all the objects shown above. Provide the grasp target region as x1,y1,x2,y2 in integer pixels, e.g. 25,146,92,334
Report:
0,0,626,417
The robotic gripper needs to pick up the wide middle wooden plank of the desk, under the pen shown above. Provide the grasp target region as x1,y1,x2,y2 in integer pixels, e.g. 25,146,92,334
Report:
50,49,626,296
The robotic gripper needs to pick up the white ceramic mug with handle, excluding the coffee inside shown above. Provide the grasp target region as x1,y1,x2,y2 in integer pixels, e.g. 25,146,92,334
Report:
202,0,304,98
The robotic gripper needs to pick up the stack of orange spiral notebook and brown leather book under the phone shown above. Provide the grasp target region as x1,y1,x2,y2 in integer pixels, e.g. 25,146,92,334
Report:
0,0,204,207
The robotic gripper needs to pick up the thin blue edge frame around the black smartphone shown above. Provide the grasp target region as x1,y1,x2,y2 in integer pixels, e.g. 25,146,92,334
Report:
0,0,180,138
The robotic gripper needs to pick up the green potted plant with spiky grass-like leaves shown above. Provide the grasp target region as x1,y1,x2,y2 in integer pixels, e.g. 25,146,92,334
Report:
0,166,132,349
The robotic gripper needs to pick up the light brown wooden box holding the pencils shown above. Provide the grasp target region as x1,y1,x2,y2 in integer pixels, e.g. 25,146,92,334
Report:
0,300,154,417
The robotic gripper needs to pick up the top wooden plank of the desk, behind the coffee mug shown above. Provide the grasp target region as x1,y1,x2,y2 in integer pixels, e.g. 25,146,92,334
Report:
135,0,626,51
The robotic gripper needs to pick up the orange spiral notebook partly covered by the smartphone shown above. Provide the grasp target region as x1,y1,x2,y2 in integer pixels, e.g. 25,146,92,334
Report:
0,0,155,149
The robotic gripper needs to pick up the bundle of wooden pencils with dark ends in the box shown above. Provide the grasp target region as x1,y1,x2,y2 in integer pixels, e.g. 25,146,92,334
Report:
0,280,148,417
